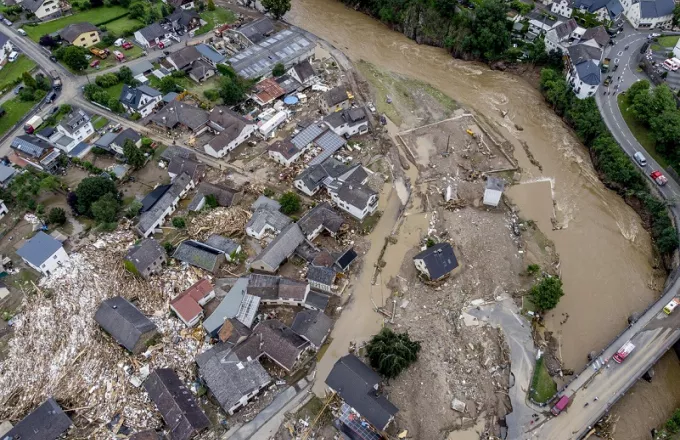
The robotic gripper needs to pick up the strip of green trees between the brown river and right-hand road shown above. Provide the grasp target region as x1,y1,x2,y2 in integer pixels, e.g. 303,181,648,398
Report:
540,69,678,254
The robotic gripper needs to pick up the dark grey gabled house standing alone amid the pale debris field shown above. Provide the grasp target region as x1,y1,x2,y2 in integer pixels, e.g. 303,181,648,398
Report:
94,296,158,354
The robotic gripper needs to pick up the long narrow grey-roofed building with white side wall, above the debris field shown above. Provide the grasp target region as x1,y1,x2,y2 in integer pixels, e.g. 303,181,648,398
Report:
135,173,195,237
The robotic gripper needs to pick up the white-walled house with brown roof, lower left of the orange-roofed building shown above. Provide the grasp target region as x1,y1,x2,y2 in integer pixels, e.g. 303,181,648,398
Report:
203,106,257,157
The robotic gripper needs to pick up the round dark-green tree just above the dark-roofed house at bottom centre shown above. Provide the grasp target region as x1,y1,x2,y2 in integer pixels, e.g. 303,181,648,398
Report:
366,327,420,379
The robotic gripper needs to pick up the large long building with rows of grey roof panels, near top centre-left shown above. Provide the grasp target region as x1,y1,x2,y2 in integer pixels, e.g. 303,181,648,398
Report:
229,29,316,79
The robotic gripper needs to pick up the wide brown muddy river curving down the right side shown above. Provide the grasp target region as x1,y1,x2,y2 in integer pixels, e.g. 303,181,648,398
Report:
286,0,680,438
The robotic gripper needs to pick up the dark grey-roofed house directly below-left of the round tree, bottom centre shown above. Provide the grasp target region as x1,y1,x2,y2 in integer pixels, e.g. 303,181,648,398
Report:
326,354,399,430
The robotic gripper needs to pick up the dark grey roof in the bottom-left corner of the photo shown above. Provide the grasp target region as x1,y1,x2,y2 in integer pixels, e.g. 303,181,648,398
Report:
2,397,72,440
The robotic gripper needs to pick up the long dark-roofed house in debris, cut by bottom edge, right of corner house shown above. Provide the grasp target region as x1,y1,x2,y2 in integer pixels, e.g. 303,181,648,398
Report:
144,368,210,440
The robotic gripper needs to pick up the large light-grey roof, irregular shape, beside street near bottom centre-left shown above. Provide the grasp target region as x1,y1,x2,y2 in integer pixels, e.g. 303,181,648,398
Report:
196,343,271,411
